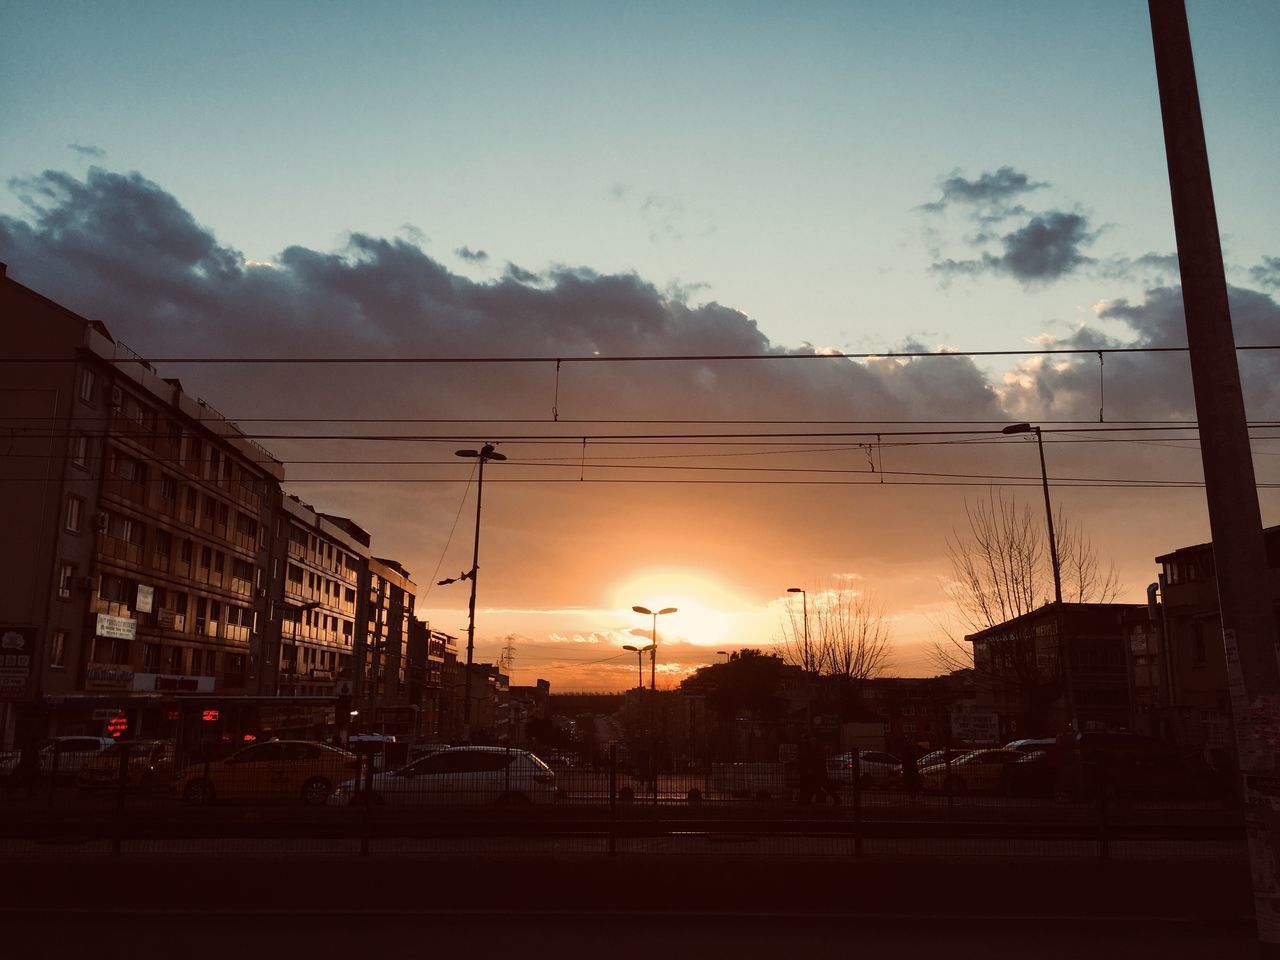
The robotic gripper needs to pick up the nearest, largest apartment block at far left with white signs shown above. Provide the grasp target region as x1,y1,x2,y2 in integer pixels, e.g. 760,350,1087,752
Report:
0,275,284,742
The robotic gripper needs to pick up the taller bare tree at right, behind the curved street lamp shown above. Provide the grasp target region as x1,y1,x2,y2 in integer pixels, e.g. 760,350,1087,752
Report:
933,493,1119,718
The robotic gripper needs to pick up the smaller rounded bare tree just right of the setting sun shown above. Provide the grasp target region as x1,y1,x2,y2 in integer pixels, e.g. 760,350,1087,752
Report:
781,588,892,681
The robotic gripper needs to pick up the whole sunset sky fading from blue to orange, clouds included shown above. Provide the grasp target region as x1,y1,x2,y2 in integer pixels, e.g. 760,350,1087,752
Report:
0,0,1280,690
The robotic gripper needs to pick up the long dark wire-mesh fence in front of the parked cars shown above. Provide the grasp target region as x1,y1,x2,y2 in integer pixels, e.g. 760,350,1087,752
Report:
0,741,1245,863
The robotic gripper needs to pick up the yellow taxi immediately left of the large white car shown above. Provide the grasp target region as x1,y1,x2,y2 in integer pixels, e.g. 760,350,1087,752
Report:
172,740,358,805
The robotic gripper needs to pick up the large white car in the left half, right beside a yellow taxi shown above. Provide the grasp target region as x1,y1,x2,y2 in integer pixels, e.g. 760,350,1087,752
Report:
329,746,559,806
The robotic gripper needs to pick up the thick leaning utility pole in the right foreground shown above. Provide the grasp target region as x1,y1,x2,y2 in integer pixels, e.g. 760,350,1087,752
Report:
1148,0,1280,957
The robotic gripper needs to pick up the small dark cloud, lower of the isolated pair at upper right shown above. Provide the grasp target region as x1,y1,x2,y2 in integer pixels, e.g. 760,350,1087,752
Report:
931,210,1097,285
